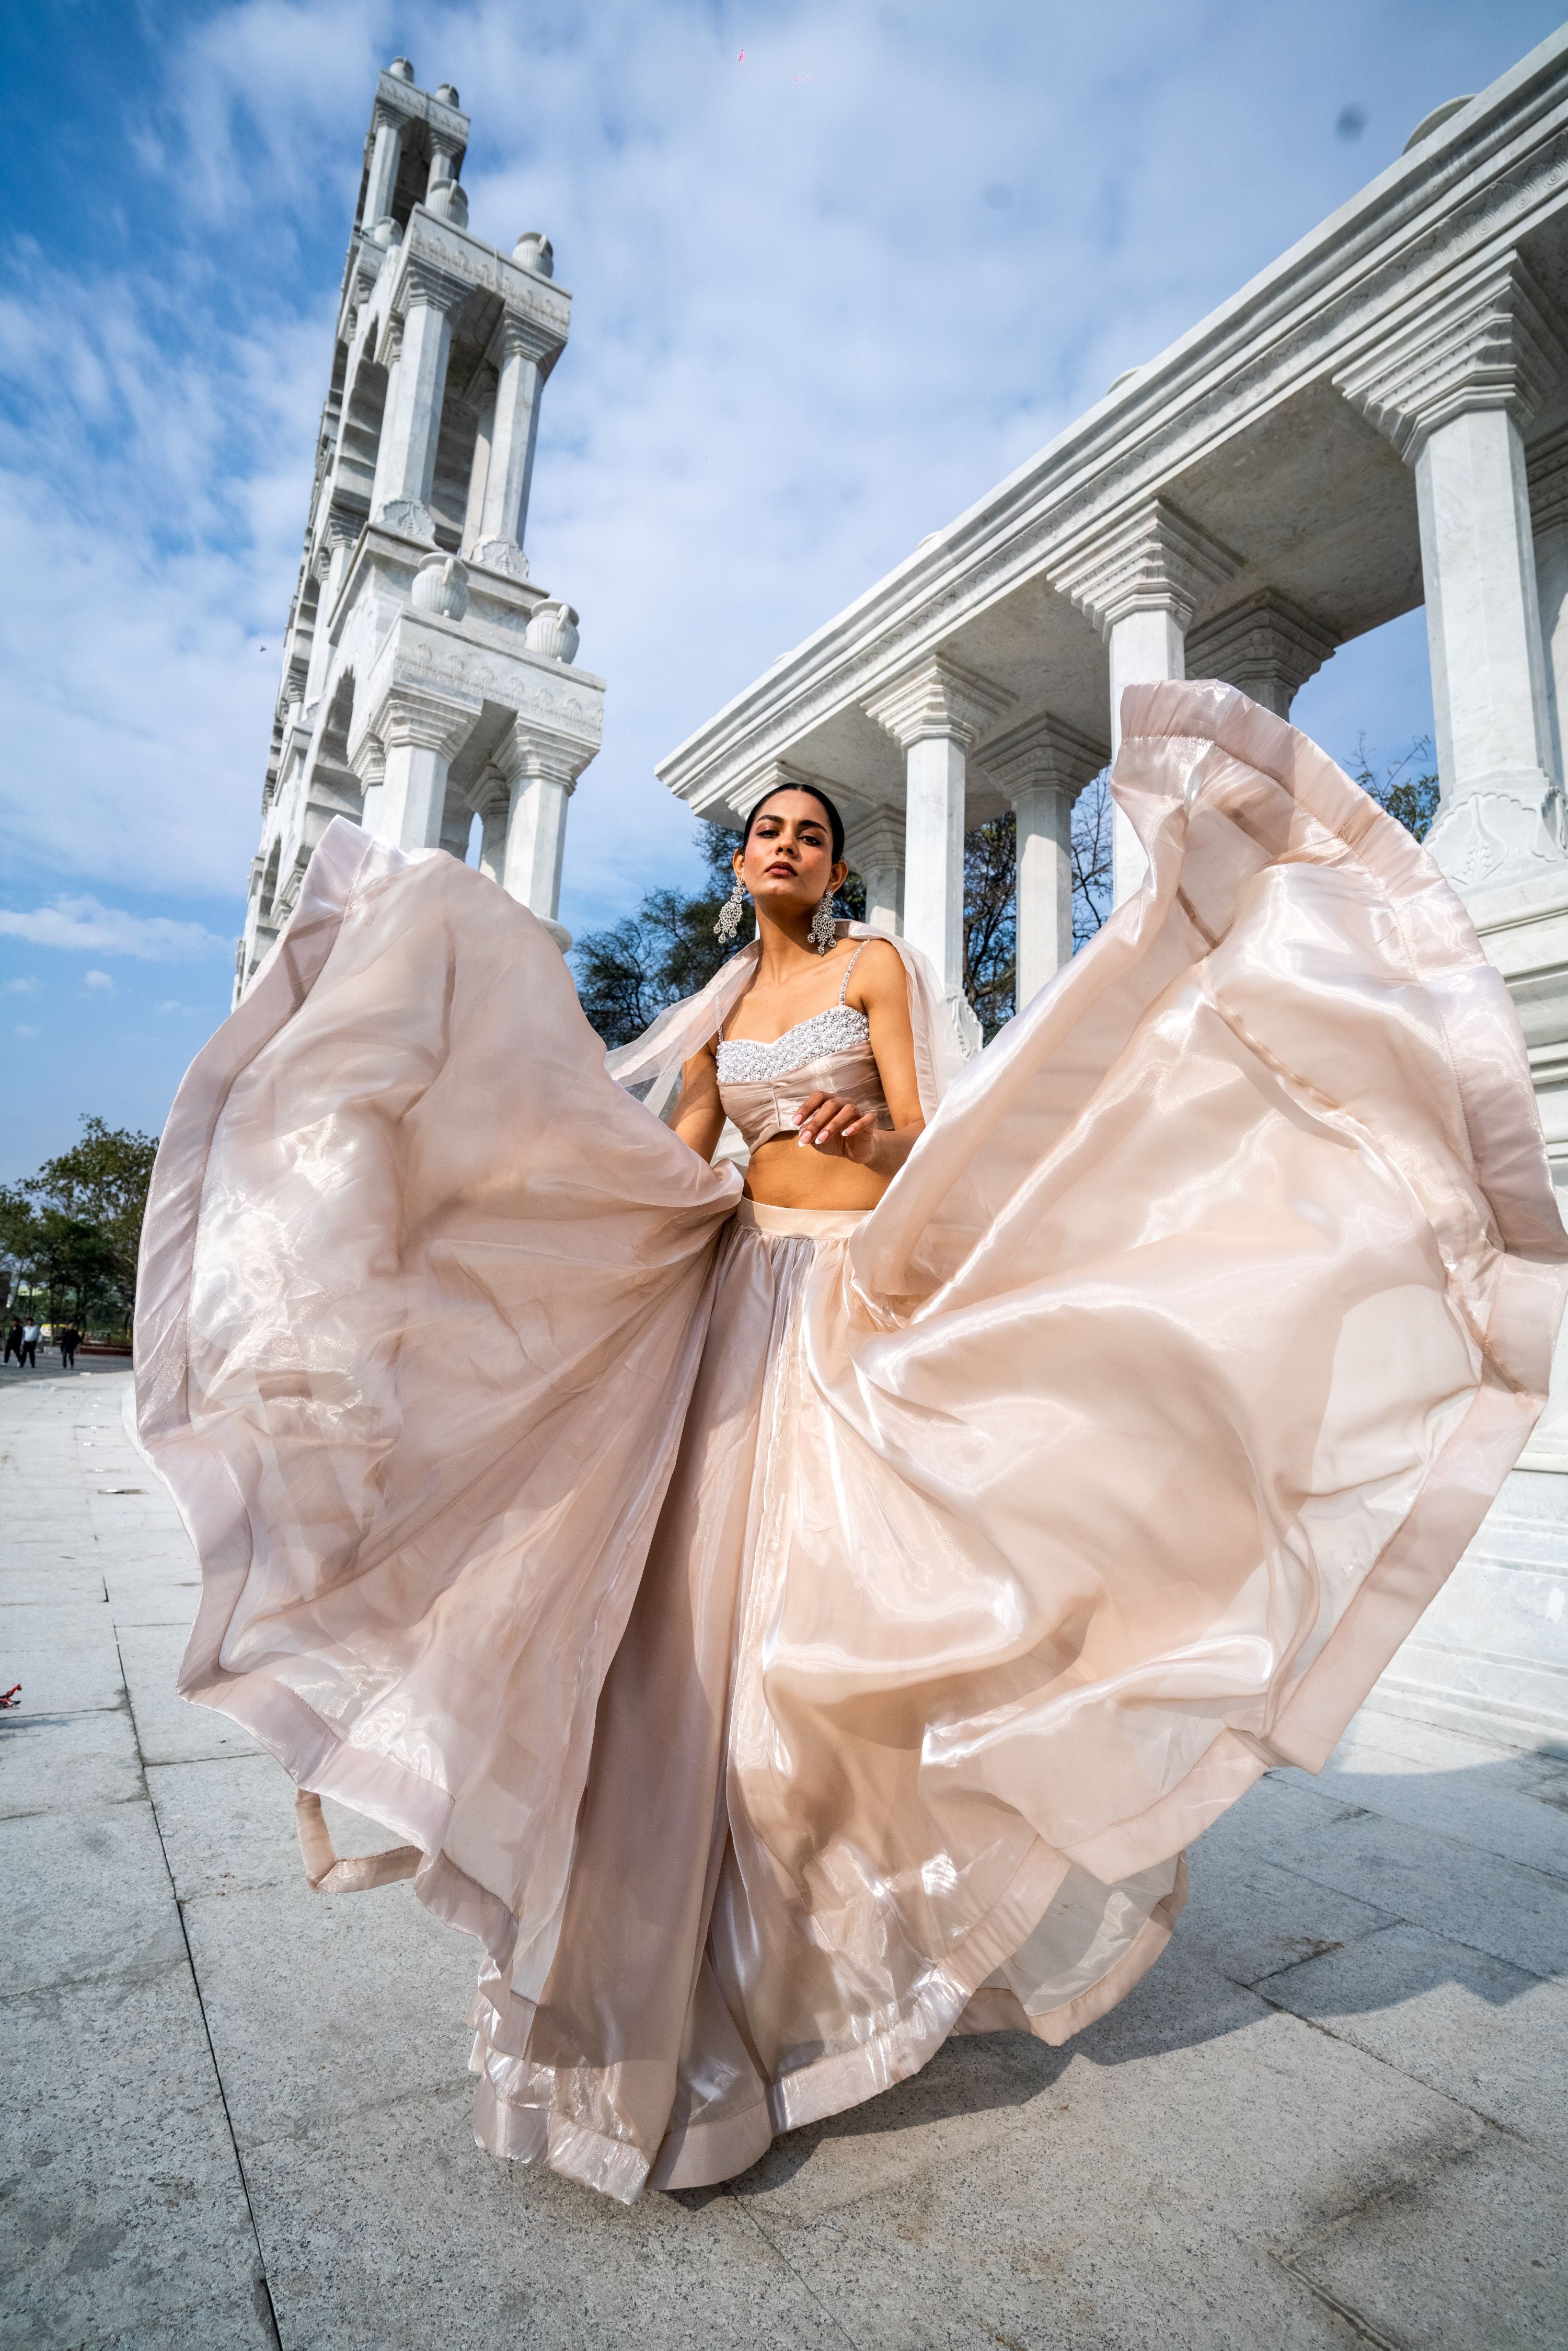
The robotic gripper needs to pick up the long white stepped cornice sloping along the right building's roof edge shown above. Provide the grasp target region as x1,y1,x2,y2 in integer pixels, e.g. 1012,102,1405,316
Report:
658,28,1568,804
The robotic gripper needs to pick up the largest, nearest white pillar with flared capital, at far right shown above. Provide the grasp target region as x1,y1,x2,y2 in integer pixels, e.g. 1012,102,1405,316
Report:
1335,254,1568,891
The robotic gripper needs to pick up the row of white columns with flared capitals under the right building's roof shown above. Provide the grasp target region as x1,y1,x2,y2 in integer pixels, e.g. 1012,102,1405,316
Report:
846,251,1568,1025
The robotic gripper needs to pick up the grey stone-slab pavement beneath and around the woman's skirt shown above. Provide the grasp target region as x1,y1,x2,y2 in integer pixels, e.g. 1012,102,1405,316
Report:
0,1370,1568,2351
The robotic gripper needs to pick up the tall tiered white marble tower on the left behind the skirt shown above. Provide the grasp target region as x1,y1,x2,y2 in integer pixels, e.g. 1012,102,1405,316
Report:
235,56,604,999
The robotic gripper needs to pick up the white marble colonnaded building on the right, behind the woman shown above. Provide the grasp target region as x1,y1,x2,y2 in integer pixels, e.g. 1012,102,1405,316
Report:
658,28,1568,1737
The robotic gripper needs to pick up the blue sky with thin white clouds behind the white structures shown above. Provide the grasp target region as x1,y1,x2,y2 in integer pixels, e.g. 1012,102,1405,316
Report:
0,0,1557,1180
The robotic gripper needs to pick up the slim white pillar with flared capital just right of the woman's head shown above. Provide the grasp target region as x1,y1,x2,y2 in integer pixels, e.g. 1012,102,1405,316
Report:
865,653,1013,1018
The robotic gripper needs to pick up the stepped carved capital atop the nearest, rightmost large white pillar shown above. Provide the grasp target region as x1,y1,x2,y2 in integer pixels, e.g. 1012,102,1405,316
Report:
1333,251,1568,466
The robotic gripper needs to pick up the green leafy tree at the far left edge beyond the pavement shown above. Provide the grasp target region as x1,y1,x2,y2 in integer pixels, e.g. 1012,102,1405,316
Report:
0,1119,157,1331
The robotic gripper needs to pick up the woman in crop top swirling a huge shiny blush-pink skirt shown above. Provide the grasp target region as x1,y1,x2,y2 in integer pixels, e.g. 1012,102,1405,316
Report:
136,684,1568,2198
